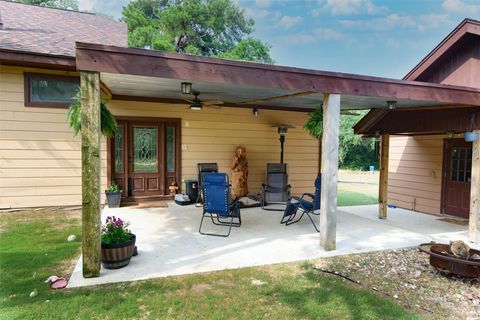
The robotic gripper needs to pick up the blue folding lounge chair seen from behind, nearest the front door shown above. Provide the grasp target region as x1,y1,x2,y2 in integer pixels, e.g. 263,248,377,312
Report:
198,172,242,237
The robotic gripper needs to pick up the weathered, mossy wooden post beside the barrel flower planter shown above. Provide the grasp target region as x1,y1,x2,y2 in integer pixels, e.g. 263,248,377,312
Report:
80,72,101,278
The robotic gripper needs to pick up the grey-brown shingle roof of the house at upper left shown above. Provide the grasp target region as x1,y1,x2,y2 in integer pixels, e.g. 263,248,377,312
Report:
0,0,128,57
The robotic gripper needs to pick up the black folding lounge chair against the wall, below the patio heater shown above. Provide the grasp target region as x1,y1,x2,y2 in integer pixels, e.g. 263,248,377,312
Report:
262,163,291,211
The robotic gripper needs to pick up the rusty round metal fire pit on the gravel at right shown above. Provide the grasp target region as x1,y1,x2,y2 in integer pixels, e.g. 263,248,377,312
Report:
418,243,480,278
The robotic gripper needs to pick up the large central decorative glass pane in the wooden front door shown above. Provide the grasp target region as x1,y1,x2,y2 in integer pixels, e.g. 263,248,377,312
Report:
133,127,158,172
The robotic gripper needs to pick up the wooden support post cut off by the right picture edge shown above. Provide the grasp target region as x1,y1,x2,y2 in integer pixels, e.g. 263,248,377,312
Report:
468,131,480,243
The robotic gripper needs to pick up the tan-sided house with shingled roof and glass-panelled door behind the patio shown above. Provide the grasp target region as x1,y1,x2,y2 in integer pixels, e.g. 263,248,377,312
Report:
0,0,321,208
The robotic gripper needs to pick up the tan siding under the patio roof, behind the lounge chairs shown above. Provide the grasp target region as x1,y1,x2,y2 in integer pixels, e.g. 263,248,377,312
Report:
109,101,319,194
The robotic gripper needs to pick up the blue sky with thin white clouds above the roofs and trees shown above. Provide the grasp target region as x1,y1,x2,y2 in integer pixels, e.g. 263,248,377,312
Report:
79,0,480,79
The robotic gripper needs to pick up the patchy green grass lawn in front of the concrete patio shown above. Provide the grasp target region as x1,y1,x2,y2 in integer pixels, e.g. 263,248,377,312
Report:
0,210,417,319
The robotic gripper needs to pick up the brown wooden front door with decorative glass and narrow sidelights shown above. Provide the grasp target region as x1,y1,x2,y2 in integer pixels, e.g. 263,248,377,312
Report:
109,119,180,198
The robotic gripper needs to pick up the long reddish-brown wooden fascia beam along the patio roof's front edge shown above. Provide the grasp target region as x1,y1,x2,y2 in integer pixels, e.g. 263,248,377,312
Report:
76,42,480,105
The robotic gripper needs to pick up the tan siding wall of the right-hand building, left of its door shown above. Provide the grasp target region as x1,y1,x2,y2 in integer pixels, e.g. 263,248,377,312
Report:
388,135,445,214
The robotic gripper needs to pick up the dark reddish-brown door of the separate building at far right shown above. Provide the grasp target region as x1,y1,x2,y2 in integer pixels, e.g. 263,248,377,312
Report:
442,139,472,218
